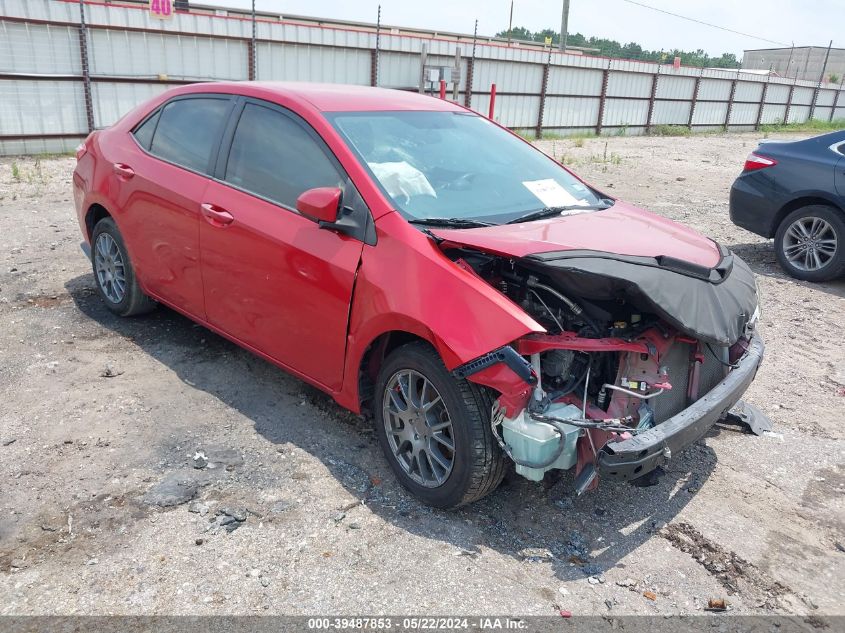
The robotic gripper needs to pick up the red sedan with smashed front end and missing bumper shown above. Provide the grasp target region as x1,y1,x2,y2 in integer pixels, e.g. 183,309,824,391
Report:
73,83,764,507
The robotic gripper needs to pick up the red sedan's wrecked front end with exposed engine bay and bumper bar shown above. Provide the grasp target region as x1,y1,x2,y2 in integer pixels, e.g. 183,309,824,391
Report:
448,244,765,494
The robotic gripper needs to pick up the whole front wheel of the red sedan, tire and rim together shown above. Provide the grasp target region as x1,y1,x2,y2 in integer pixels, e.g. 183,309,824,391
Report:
374,343,506,508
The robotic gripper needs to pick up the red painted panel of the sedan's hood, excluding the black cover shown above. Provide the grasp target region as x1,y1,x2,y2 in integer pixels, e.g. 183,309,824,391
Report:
431,201,722,268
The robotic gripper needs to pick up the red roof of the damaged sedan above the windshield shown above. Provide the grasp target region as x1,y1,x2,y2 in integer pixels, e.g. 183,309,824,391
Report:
180,81,466,112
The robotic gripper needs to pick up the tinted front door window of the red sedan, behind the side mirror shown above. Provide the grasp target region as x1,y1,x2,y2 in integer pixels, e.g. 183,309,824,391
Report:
224,103,346,209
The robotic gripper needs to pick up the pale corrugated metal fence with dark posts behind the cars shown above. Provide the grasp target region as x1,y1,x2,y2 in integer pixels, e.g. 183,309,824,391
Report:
0,0,845,155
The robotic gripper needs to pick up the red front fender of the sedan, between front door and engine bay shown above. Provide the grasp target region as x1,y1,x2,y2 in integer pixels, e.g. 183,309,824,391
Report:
338,213,546,411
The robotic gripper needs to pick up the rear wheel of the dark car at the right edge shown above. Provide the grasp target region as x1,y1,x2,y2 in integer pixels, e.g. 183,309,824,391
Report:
775,204,845,281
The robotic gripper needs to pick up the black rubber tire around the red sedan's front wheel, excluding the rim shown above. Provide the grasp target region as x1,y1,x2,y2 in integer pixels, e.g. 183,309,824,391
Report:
373,342,507,509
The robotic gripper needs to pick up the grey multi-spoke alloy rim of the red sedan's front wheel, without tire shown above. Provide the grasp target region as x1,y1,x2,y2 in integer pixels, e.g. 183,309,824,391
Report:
382,369,455,488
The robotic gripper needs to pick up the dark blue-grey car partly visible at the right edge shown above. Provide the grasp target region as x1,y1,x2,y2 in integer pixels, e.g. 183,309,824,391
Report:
730,130,845,281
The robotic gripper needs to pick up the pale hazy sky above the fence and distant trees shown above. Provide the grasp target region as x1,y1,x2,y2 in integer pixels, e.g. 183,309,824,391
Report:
198,0,845,56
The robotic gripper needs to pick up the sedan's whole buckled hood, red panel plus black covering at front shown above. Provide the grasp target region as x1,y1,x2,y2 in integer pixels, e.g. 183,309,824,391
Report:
431,202,757,346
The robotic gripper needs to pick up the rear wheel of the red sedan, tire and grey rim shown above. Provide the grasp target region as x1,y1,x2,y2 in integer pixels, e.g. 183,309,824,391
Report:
91,218,157,317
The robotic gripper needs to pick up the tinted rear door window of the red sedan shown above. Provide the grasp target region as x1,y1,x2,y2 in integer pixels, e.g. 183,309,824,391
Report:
147,97,230,173
